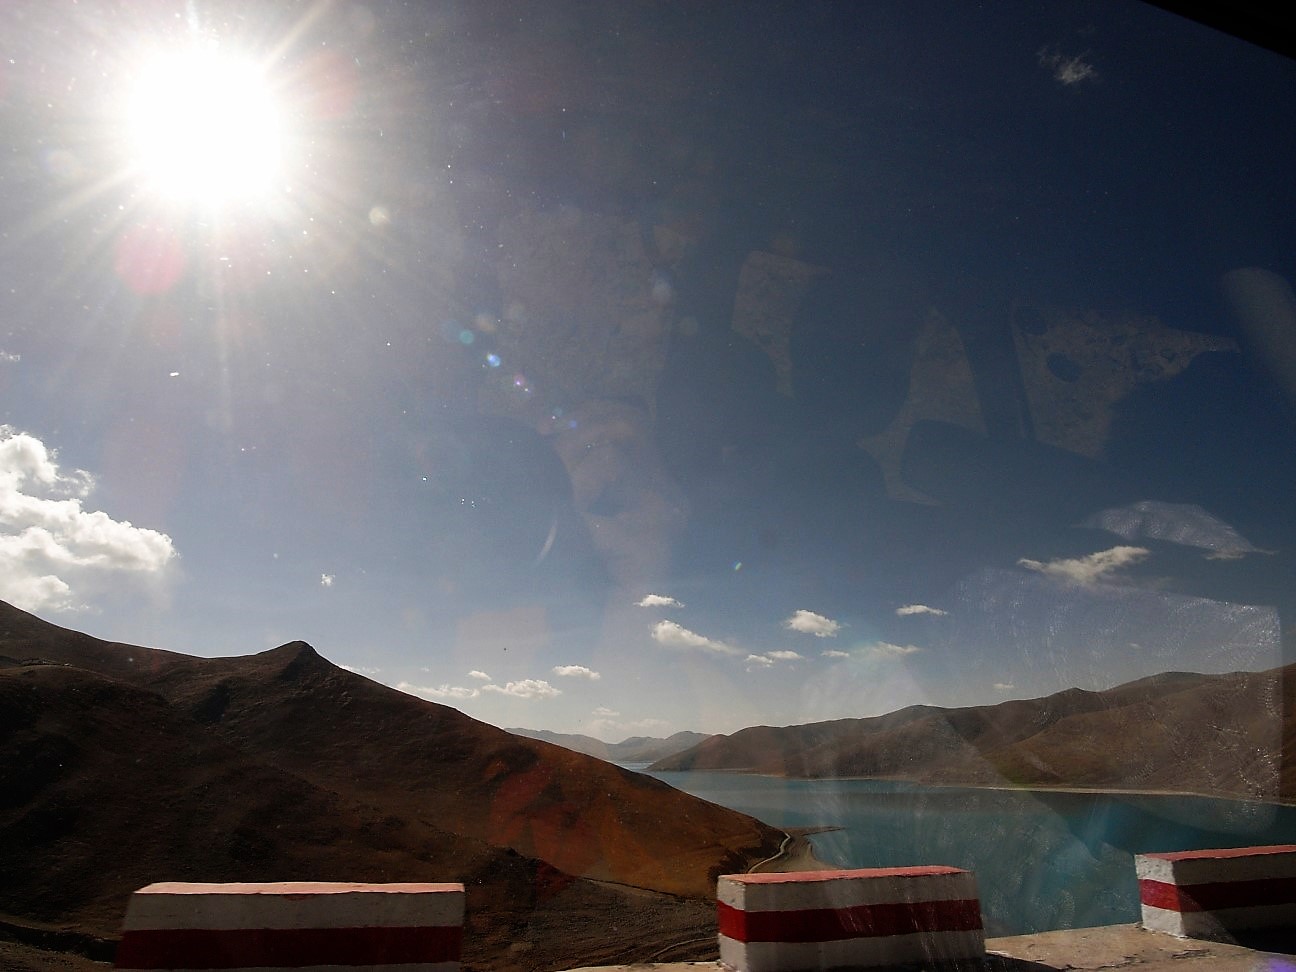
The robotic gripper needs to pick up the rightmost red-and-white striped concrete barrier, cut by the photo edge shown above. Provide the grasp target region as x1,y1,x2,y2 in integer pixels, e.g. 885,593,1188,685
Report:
1134,844,1296,938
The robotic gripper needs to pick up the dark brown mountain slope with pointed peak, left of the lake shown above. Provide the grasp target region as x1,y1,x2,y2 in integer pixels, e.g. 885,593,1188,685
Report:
0,603,784,969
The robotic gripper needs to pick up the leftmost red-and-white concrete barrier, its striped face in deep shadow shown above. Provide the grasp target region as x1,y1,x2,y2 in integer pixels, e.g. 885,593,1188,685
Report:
117,883,464,972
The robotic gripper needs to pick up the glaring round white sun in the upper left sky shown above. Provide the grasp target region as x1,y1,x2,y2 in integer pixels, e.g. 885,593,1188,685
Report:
127,48,284,205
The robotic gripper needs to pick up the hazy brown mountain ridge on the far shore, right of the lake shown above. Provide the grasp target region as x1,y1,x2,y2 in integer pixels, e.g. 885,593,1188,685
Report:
651,665,1296,801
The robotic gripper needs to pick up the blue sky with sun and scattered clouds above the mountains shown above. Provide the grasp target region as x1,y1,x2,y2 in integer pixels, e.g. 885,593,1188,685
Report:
0,3,1296,740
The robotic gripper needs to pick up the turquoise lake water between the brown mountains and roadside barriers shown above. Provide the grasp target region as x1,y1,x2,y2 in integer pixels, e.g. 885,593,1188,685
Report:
627,766,1296,936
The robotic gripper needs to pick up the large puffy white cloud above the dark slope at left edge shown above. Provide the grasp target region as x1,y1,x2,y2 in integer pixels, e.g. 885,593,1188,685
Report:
0,425,176,610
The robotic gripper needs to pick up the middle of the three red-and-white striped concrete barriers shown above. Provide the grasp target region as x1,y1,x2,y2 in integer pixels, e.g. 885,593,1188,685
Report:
715,867,985,972
